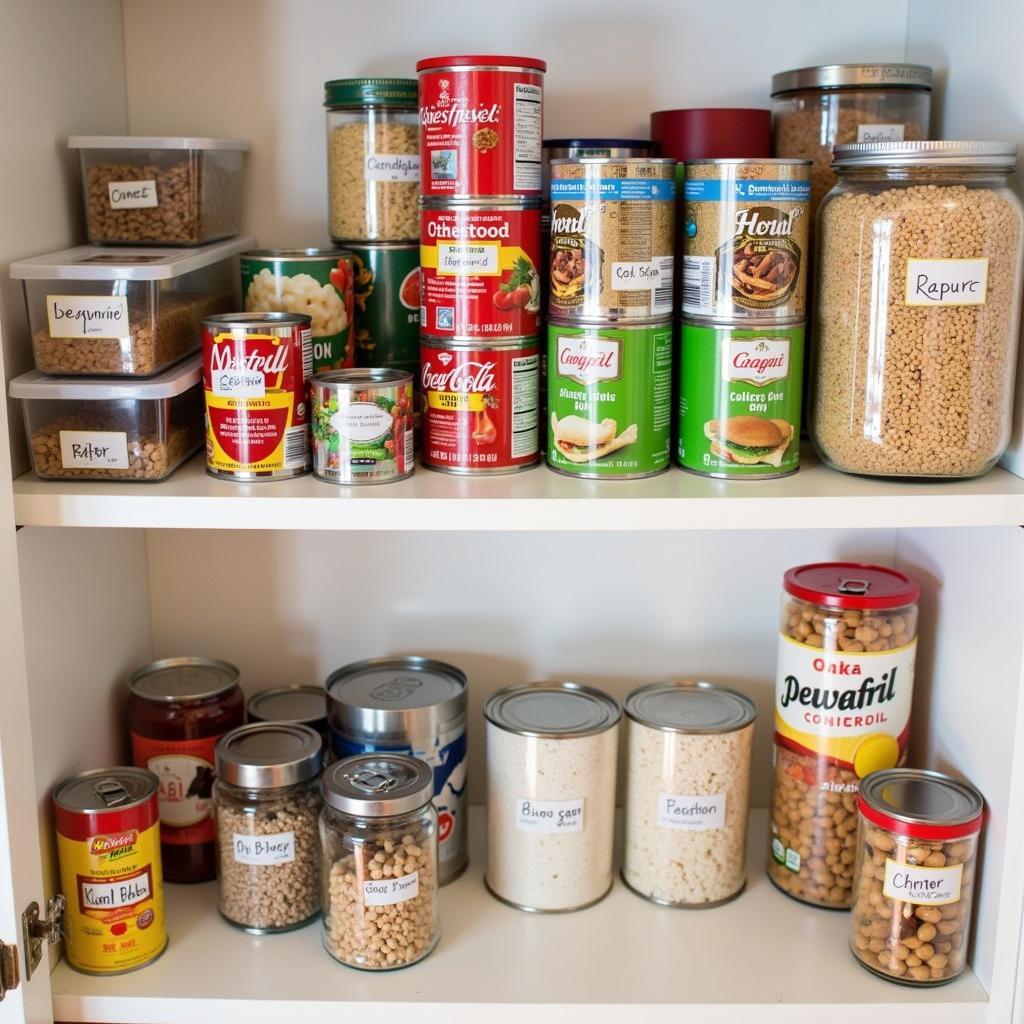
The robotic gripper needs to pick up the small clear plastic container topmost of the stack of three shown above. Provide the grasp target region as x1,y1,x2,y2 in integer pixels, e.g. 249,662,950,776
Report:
68,135,249,246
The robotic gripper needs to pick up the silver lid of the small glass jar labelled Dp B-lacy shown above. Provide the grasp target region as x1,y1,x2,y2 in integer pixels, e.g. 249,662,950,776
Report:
214,722,323,790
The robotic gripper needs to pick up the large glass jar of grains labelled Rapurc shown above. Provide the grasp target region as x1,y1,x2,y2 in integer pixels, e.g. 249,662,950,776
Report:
811,142,1024,477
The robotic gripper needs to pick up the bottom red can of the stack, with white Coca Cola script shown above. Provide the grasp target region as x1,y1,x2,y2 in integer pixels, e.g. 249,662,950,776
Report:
420,338,541,473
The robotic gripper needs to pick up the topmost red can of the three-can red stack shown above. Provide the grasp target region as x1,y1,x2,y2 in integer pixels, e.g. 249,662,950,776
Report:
416,55,547,199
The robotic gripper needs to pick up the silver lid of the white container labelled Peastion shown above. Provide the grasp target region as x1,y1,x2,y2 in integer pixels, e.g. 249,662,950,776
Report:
624,681,758,735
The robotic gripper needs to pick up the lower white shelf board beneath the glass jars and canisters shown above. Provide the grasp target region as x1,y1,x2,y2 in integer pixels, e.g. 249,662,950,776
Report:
52,808,988,1024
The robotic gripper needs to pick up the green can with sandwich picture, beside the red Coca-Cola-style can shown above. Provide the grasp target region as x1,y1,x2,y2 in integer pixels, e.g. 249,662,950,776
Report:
546,322,672,479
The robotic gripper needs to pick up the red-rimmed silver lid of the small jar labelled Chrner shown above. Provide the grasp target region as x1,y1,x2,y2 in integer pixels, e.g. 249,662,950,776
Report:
858,768,985,841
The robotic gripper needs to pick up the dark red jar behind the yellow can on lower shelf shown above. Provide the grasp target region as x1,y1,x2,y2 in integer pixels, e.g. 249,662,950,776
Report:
128,657,245,882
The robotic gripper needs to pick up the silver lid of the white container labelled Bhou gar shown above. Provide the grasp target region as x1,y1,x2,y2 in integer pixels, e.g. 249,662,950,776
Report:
483,683,622,739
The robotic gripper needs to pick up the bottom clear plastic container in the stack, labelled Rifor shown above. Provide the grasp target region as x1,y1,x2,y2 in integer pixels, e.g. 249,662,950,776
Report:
10,355,203,480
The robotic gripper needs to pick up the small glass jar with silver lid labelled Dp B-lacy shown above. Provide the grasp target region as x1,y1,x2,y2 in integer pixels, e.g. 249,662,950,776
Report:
213,722,323,934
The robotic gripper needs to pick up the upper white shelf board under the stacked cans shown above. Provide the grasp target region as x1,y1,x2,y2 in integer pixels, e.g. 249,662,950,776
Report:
14,453,1024,530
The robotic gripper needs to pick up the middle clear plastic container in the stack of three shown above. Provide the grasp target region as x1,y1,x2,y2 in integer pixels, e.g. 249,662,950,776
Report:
10,238,253,377
